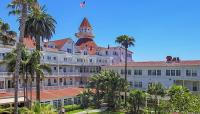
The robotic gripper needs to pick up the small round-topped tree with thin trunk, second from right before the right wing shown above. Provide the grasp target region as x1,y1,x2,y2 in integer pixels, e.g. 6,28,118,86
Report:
147,83,166,114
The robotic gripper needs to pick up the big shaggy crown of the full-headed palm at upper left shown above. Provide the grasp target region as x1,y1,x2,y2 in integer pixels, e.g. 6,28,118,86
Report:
25,4,56,43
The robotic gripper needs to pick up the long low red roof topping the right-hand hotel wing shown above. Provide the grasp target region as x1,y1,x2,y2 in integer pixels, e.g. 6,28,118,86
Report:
111,60,200,67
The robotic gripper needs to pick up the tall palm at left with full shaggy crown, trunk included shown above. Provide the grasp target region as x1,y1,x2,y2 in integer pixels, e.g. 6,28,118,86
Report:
25,7,56,102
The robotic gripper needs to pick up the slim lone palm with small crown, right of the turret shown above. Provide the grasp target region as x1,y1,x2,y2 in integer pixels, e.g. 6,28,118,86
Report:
115,35,135,106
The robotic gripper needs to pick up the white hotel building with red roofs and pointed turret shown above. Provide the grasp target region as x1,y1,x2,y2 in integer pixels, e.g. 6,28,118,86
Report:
0,18,200,106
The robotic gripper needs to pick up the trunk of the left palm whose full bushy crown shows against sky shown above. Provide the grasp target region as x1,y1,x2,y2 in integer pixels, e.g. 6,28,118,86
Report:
35,36,40,102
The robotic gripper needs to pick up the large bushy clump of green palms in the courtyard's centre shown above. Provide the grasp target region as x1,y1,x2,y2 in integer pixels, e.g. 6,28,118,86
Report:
89,71,128,110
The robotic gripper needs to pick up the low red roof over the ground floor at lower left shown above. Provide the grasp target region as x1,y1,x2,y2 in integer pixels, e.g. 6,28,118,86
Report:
0,87,84,101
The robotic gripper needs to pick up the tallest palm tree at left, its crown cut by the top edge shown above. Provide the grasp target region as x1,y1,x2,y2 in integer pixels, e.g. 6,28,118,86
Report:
8,0,37,114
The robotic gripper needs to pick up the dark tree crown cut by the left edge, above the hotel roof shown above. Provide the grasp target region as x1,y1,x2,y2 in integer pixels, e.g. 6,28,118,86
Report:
0,19,17,45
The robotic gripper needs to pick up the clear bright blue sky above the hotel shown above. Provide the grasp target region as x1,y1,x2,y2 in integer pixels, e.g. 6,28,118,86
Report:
0,0,200,61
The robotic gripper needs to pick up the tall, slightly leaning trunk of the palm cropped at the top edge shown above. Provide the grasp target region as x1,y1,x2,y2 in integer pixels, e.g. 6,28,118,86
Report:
14,3,27,114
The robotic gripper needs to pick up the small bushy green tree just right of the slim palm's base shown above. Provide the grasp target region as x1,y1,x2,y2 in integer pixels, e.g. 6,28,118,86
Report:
128,89,146,114
